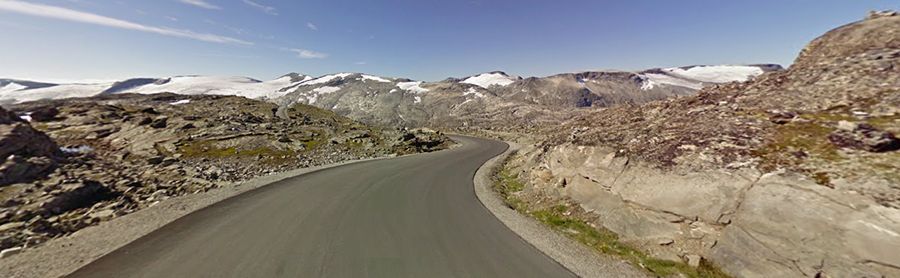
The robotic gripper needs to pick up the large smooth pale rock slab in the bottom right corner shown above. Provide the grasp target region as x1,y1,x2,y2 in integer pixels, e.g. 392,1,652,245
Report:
708,174,900,277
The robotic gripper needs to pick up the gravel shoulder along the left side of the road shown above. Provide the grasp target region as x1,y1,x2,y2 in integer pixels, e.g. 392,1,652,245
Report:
0,152,436,277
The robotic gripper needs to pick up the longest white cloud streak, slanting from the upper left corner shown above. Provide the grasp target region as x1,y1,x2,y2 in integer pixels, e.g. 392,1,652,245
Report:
0,0,253,45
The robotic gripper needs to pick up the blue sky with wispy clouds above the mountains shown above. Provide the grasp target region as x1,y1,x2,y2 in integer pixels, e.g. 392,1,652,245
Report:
0,0,900,81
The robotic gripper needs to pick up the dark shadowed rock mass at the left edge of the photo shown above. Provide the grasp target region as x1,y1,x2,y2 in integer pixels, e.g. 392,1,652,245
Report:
0,108,59,187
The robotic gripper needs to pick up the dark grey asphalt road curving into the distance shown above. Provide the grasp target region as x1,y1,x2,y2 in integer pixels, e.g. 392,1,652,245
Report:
70,137,574,277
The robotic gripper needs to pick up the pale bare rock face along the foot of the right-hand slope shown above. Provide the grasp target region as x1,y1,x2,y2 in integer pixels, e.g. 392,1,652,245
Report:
512,145,900,277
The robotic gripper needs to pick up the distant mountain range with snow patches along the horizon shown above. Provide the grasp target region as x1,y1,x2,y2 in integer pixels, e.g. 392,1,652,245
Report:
0,65,781,126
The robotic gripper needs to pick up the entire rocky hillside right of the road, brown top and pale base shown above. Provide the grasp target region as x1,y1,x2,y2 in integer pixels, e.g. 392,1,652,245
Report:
502,12,900,277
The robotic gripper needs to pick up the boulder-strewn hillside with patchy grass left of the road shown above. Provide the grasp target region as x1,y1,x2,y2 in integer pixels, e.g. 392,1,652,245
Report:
0,94,449,254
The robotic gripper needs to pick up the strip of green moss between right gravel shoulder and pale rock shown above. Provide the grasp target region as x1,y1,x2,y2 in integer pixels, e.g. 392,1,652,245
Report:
494,162,729,277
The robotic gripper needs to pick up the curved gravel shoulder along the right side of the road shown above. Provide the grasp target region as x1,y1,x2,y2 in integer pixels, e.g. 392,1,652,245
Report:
473,141,647,277
